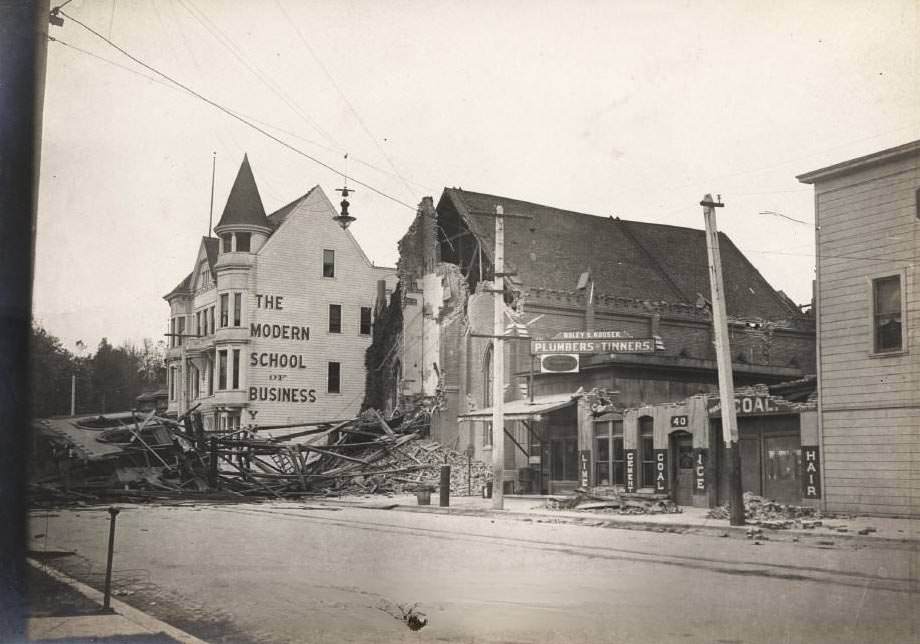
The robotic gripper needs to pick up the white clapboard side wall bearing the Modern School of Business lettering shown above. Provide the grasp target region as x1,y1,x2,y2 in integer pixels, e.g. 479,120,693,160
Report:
246,189,392,425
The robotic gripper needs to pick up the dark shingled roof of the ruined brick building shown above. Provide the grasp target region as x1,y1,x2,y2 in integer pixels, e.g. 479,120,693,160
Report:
437,188,797,320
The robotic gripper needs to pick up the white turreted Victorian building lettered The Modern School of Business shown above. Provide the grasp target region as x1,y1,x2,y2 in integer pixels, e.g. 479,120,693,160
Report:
164,157,394,431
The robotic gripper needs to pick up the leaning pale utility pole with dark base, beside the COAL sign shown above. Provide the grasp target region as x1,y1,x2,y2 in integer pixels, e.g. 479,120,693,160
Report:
700,194,744,525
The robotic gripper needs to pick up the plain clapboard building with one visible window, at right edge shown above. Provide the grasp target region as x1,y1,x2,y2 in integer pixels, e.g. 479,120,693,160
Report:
798,141,920,516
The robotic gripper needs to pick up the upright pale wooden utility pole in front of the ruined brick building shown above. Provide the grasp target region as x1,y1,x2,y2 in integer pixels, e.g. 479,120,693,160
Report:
492,206,505,510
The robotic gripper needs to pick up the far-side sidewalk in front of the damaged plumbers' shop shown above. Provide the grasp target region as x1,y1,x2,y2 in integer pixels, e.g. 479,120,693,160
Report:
311,494,920,550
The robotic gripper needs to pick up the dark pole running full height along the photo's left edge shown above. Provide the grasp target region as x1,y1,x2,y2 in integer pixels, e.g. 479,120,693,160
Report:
0,0,49,642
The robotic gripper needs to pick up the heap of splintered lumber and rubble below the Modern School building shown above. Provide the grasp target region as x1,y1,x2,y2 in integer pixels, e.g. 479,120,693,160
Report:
30,410,491,505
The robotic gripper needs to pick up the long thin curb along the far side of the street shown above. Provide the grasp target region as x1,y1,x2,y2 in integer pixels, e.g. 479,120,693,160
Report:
324,500,920,550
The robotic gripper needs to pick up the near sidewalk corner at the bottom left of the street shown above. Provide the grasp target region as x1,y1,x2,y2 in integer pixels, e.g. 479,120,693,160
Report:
27,559,204,644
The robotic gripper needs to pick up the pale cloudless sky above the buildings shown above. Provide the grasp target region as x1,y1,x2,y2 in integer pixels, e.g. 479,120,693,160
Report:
34,0,920,351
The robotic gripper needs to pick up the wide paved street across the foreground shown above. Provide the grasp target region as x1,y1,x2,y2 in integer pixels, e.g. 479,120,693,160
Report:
32,503,920,644
